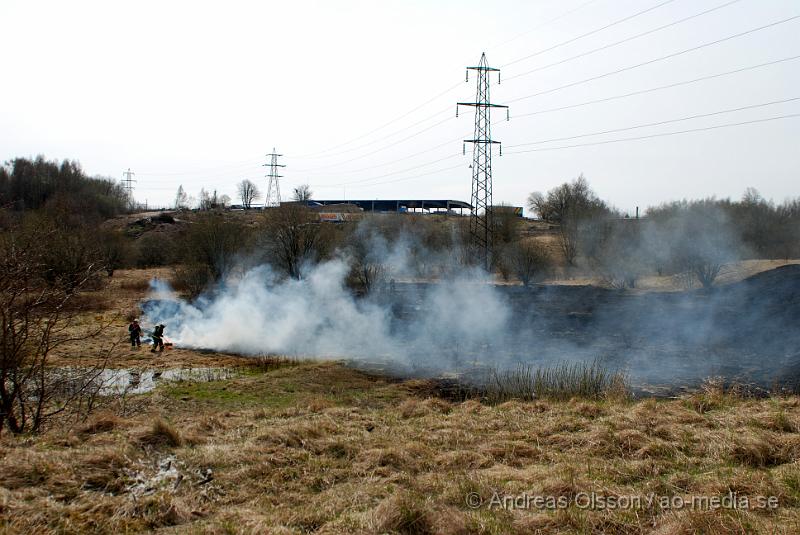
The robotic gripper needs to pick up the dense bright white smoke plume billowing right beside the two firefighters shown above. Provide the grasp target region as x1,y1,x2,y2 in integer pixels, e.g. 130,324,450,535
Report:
144,253,509,368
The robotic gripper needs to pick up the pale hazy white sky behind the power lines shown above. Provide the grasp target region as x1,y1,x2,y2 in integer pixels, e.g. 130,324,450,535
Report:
0,0,800,212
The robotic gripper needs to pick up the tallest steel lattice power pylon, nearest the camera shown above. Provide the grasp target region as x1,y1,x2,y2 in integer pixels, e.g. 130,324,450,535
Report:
456,53,509,271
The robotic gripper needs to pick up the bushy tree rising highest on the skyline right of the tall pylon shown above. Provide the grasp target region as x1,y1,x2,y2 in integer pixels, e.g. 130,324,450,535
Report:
528,174,610,266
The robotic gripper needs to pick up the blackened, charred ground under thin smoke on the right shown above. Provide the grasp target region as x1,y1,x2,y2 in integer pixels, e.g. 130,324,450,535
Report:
380,265,800,391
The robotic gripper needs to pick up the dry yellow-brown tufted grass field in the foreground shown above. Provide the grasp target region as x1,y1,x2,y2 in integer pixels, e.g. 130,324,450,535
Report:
0,272,800,534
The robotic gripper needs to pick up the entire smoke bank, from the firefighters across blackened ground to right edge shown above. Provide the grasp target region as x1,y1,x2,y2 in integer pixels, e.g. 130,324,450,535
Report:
143,217,800,390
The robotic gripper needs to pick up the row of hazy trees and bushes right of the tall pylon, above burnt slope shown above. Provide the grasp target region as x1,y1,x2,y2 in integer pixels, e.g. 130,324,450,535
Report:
528,175,800,287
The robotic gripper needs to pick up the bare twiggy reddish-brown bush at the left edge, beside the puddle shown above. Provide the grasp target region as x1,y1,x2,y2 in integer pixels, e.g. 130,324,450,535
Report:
0,225,110,433
